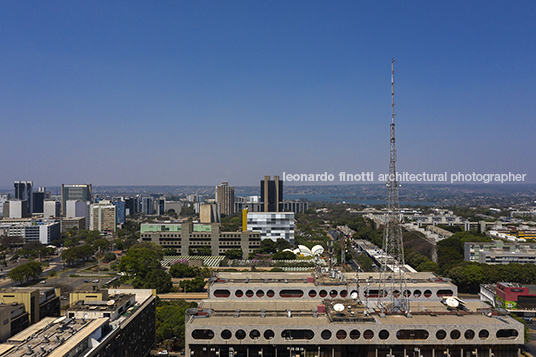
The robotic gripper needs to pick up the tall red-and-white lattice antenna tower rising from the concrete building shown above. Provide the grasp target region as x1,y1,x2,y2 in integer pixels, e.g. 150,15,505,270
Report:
378,59,409,313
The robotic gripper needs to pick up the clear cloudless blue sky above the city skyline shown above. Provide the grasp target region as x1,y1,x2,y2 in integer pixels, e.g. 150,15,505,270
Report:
0,0,536,186
